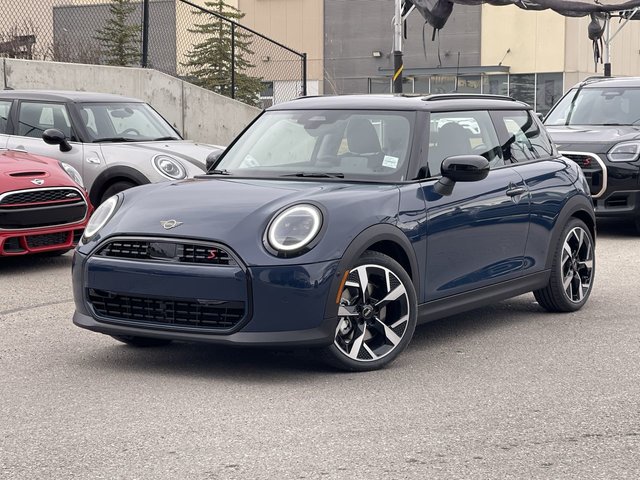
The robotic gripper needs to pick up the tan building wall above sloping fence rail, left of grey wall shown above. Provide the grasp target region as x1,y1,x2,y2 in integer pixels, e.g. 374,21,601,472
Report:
238,0,324,80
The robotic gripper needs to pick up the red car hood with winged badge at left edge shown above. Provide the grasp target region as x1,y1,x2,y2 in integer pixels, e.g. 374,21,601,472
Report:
0,151,79,193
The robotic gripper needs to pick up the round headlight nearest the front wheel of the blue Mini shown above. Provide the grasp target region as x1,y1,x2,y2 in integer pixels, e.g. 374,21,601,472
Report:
267,204,322,254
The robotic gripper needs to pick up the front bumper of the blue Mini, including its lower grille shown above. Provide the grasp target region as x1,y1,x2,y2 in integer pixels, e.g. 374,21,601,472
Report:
72,249,340,346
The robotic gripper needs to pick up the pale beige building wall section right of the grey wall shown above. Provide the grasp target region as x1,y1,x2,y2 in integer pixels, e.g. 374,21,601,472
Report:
480,5,564,73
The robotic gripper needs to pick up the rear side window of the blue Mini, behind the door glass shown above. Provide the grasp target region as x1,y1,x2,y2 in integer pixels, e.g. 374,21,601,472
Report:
495,110,553,163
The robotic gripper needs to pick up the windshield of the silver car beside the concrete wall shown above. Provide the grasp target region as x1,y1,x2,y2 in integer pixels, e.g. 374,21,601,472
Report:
79,103,180,142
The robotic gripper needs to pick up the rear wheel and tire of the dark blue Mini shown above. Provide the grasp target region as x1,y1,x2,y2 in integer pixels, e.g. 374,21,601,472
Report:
533,218,596,312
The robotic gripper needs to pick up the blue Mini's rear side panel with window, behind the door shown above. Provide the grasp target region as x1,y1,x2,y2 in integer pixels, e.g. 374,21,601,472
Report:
491,109,575,273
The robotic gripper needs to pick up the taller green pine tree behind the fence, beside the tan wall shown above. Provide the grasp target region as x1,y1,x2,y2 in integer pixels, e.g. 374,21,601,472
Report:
182,0,263,106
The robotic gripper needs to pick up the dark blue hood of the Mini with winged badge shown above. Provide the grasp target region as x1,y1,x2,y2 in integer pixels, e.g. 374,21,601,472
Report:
101,177,399,263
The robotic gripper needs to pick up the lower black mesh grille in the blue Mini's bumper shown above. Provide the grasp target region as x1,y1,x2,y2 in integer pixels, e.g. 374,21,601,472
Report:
89,289,244,330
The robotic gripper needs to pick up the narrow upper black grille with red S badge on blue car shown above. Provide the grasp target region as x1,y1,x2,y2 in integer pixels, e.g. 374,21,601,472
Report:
99,240,237,265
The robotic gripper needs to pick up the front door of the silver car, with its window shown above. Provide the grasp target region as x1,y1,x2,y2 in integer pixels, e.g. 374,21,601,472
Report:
7,100,84,176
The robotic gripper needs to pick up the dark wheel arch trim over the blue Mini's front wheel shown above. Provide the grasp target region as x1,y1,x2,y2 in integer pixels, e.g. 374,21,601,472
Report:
325,223,420,318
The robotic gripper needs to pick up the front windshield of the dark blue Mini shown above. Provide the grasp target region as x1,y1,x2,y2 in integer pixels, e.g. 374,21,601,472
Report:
215,110,415,181
